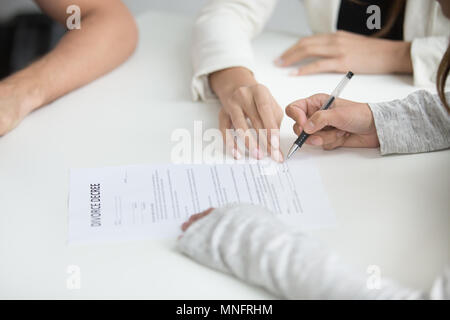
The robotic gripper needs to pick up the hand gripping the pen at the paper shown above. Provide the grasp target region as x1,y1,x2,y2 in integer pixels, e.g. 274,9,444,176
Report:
286,94,380,150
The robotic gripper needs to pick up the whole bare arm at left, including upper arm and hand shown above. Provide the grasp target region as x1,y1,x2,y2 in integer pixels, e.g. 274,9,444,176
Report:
0,0,138,135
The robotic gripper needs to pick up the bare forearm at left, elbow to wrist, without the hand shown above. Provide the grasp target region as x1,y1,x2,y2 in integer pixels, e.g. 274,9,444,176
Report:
0,2,137,114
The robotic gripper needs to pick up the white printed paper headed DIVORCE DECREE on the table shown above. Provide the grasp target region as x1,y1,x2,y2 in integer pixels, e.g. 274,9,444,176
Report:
69,161,335,243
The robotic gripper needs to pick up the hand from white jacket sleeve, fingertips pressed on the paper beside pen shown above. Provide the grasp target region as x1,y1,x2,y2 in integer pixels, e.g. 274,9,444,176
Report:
209,67,283,162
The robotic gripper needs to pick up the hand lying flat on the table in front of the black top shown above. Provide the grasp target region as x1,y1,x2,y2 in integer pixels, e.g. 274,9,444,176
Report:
275,31,413,75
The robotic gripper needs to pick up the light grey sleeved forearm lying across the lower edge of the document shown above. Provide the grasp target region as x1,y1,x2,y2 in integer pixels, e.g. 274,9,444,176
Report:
179,205,422,299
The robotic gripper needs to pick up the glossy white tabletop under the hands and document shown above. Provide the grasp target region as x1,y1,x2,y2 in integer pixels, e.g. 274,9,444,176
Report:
0,13,450,299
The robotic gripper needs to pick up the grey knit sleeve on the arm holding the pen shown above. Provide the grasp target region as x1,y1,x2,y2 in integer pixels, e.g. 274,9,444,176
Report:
369,90,450,155
